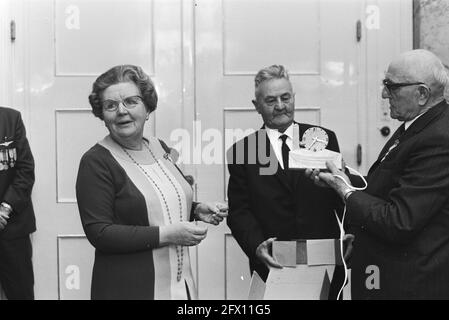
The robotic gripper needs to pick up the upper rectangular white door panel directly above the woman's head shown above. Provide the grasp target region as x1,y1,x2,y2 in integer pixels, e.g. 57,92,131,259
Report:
54,0,154,76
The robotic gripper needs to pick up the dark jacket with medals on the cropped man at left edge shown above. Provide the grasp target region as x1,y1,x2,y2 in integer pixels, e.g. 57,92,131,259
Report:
0,107,36,239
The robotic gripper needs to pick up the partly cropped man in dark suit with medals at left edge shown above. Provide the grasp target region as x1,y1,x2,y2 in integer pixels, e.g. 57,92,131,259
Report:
0,107,36,300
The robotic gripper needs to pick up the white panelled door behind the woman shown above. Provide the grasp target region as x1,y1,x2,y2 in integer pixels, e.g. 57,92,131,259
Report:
22,0,186,299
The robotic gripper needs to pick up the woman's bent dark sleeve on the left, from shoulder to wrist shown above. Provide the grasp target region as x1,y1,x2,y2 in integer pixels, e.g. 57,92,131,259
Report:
76,153,159,253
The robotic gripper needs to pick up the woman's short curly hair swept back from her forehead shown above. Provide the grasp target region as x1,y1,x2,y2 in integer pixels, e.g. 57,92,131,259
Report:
89,64,157,120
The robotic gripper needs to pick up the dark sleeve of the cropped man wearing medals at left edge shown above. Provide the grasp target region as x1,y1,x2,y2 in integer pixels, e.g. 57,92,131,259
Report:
3,113,34,213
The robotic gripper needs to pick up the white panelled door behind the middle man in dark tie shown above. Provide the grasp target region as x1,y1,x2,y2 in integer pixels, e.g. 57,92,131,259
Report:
195,0,363,299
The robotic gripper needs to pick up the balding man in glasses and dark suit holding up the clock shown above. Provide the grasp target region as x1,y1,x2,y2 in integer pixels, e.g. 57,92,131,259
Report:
313,50,449,299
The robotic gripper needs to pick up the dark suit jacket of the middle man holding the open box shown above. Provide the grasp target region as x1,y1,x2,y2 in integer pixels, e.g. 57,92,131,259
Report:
227,123,341,278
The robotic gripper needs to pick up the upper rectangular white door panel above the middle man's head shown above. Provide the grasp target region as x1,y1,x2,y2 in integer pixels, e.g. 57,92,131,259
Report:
222,0,320,75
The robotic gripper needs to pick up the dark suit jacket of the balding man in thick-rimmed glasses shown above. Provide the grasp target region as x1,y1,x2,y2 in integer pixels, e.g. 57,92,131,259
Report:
347,102,449,299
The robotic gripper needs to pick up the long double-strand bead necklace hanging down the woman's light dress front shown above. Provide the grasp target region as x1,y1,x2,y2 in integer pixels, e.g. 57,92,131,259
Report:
122,142,184,281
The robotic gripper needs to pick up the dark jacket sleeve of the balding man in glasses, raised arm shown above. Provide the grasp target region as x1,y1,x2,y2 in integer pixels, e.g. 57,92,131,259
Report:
347,137,449,244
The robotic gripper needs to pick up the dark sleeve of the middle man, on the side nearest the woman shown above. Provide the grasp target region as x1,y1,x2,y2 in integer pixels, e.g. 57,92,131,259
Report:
226,146,266,259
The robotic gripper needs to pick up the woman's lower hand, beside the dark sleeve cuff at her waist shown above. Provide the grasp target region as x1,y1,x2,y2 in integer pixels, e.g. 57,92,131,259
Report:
159,221,207,247
